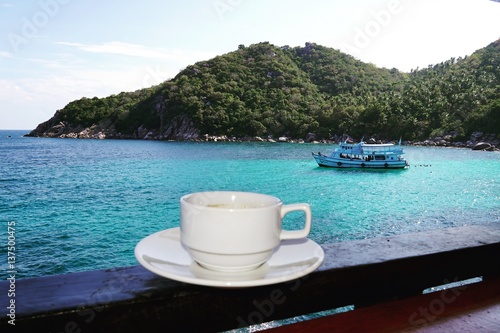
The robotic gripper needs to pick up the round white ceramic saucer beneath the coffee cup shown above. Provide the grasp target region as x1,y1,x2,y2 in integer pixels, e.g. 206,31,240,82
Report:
135,228,324,288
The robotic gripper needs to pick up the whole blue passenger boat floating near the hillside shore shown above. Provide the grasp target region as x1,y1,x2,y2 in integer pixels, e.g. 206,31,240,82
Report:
312,140,409,169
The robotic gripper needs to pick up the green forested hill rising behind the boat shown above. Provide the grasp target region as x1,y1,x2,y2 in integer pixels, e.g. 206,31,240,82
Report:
29,40,500,140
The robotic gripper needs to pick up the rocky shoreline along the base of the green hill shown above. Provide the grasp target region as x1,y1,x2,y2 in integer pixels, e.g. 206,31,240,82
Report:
25,122,500,151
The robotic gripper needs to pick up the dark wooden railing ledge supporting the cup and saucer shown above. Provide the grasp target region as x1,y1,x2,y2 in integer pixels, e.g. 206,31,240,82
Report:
0,223,500,333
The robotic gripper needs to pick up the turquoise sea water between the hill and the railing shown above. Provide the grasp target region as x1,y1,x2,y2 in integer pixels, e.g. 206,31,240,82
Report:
0,131,500,278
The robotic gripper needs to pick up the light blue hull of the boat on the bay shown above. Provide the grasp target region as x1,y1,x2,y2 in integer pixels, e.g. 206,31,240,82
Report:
312,153,408,169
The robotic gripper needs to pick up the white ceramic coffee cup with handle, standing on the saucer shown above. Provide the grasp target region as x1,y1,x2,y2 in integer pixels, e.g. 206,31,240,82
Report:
180,191,312,272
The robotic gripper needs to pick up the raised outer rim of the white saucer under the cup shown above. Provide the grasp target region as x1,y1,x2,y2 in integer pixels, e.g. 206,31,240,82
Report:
134,227,325,288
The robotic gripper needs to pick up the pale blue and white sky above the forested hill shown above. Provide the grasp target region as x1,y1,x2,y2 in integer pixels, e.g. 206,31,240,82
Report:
0,0,500,129
